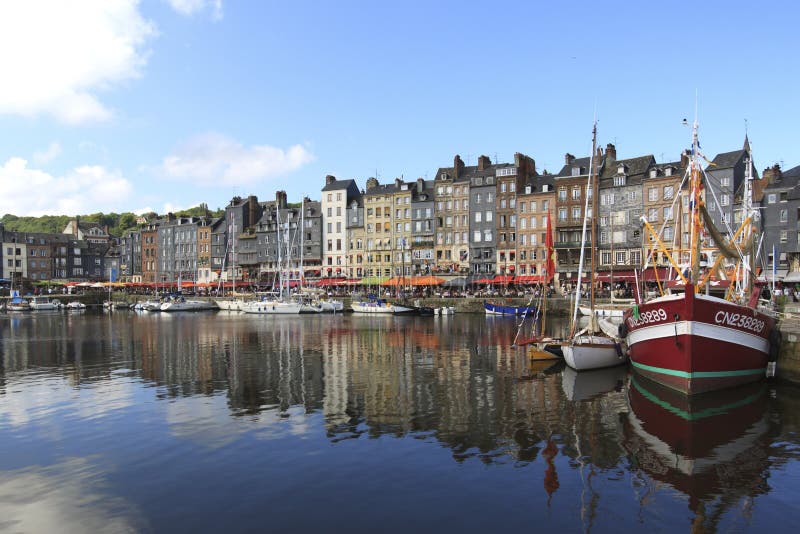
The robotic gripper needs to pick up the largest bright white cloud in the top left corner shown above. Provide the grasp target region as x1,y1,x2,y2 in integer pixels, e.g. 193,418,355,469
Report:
0,0,156,124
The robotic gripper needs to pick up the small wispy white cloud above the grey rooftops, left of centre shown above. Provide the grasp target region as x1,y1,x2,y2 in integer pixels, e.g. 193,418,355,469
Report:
161,133,314,185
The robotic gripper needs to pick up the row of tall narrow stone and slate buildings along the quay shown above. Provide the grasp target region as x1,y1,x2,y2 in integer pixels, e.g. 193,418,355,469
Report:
0,138,800,283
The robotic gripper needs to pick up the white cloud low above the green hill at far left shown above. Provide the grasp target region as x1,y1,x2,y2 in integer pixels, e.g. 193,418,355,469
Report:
0,158,133,216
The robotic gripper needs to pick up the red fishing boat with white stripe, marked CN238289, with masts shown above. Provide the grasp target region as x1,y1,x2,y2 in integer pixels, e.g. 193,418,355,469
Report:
621,120,777,394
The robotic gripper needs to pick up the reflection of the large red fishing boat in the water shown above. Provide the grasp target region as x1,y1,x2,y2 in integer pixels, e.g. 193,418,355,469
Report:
625,374,769,531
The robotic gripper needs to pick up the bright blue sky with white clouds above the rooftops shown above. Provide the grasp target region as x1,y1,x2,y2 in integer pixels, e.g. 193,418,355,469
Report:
0,0,800,216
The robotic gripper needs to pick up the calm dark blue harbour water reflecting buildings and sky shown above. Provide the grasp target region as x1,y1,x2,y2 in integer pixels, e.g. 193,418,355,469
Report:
0,312,800,532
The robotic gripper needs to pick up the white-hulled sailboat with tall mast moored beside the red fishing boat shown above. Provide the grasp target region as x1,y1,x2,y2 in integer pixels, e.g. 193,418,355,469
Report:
561,123,627,371
